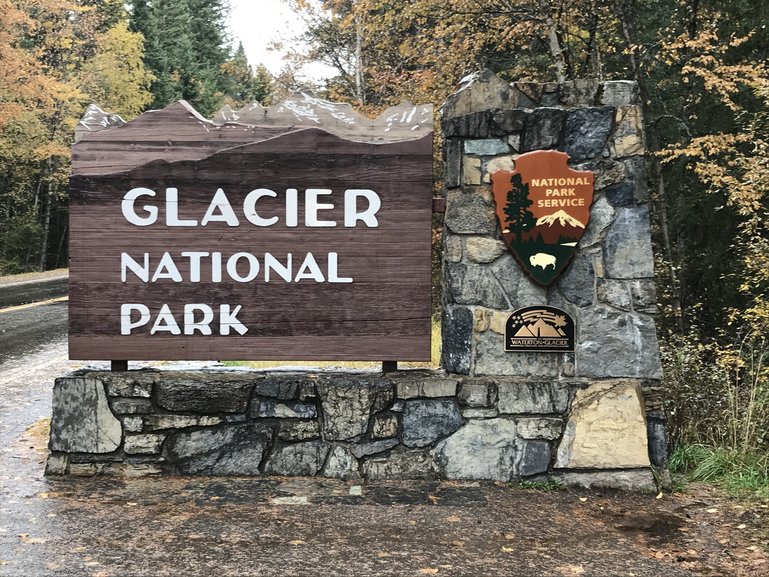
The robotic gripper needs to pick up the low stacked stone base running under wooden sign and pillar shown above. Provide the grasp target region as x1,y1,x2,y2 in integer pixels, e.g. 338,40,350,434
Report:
46,370,654,489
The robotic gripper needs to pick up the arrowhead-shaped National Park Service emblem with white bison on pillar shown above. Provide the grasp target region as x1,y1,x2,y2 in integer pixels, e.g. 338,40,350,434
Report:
491,150,594,286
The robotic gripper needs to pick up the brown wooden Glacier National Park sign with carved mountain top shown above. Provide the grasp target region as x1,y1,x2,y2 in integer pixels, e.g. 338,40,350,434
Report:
70,103,432,360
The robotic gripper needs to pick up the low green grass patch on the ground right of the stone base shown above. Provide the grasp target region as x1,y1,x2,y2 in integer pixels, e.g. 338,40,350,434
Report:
668,445,769,499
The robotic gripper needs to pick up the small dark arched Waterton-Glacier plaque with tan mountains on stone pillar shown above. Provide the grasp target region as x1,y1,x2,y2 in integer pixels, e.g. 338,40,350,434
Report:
505,305,574,353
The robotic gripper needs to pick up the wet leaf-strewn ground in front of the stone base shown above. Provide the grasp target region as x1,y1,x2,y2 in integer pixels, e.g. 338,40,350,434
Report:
0,422,769,577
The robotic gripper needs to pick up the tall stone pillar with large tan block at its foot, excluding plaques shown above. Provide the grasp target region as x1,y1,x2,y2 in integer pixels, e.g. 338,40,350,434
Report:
442,72,661,486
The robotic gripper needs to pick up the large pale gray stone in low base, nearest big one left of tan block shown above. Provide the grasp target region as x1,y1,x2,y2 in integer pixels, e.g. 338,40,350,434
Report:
433,418,517,481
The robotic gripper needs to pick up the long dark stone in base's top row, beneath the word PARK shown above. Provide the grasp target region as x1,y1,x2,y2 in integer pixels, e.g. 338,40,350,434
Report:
155,374,254,413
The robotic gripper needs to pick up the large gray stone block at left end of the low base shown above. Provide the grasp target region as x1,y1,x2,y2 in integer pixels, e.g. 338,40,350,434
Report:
48,377,123,453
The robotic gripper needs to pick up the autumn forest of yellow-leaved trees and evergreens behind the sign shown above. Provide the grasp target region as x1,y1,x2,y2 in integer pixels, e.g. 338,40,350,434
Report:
0,0,769,496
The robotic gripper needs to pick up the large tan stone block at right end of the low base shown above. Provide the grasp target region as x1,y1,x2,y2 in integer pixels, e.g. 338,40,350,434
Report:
555,380,650,469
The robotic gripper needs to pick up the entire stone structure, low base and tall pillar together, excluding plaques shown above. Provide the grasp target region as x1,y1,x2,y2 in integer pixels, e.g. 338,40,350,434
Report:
47,73,665,489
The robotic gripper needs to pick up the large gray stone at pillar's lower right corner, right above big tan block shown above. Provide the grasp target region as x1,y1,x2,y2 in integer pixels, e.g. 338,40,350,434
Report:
576,306,662,379
